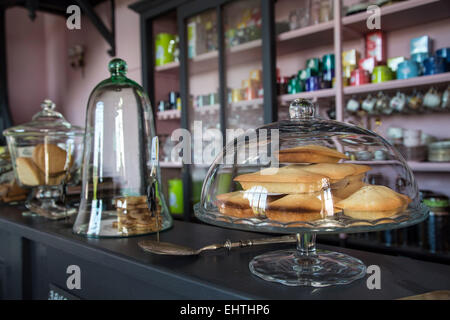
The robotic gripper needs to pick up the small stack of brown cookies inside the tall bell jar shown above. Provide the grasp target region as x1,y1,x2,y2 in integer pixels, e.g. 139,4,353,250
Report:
113,196,162,234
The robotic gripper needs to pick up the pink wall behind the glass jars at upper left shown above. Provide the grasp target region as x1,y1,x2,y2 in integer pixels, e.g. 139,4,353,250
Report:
6,0,141,126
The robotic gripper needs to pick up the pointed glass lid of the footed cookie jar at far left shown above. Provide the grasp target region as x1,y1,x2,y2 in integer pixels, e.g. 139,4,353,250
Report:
3,99,84,136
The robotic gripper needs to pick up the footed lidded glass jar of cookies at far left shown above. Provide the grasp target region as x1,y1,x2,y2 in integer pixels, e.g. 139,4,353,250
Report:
3,99,84,219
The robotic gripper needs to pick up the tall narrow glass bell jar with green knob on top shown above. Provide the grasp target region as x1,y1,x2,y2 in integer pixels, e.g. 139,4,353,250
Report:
73,59,172,237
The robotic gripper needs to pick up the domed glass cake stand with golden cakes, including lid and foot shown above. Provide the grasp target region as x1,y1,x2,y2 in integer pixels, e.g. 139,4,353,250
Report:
194,99,428,287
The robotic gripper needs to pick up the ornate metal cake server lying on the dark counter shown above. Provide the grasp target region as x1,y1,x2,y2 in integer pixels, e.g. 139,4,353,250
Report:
138,235,297,256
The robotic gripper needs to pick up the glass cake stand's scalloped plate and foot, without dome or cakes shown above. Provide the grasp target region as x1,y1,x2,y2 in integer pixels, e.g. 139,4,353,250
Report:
194,203,429,287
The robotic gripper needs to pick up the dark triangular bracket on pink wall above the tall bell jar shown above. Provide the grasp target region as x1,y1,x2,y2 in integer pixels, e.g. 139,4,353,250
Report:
75,0,116,57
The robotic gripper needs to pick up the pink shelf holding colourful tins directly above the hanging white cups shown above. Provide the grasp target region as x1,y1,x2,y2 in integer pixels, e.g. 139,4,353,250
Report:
344,72,450,95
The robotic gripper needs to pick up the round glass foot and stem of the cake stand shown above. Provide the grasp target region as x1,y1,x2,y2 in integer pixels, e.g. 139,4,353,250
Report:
249,233,366,287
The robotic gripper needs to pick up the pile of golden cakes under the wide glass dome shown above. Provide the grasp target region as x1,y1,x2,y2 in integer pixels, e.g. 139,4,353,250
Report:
216,145,410,223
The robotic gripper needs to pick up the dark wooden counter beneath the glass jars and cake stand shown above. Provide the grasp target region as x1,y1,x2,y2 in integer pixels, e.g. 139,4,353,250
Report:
0,206,450,299
